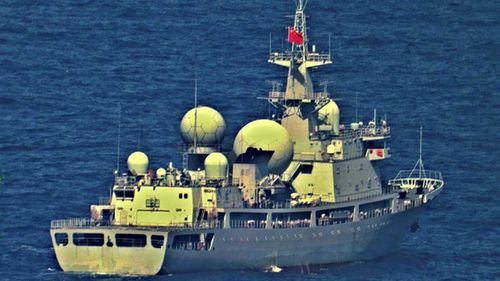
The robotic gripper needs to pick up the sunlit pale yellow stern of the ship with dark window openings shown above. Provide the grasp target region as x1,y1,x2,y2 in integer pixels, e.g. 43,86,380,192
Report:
51,227,168,275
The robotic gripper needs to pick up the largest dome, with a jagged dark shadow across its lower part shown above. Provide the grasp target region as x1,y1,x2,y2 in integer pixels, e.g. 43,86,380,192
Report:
233,119,293,174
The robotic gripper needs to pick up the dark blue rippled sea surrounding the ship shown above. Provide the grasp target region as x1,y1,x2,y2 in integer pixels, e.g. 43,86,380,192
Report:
0,0,500,281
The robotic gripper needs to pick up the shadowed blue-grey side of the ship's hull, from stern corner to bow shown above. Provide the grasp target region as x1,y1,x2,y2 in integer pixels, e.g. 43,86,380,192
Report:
162,206,423,273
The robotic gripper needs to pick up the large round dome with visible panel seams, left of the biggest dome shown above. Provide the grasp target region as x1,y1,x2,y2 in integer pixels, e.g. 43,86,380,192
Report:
180,106,226,146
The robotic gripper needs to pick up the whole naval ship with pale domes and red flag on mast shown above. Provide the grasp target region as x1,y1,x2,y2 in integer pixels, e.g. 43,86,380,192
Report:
50,0,444,275
